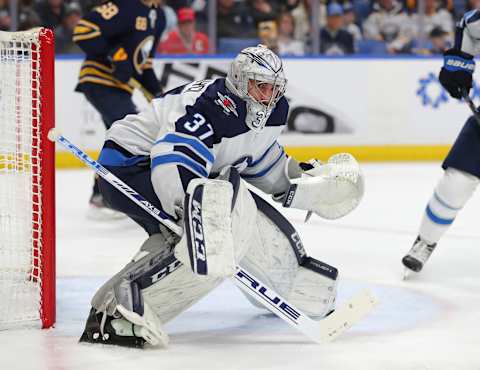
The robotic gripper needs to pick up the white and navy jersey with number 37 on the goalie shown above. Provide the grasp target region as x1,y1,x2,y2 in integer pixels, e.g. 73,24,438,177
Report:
99,78,289,217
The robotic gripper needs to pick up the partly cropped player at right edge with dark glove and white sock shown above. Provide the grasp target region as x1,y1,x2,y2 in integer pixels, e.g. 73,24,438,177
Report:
402,10,480,272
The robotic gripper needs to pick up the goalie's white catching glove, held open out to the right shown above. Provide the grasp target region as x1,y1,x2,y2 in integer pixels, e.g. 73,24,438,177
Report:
283,153,364,220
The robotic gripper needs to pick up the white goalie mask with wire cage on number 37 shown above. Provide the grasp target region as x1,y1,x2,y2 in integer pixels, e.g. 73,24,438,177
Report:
226,45,287,132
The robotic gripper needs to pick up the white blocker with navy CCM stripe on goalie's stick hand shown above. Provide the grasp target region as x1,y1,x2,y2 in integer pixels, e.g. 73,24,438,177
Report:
175,168,256,277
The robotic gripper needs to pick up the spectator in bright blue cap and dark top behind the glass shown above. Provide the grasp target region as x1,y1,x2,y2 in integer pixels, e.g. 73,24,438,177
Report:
320,3,355,55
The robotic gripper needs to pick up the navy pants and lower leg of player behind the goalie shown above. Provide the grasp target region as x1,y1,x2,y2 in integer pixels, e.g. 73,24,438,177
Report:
82,83,137,219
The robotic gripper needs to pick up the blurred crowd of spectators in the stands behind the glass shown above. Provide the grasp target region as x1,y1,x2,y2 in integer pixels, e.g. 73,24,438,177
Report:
0,0,480,56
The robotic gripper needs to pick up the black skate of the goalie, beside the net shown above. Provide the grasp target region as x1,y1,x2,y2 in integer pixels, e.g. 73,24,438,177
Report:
80,308,146,348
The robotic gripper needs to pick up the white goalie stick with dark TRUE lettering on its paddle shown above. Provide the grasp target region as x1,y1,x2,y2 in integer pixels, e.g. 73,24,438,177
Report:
48,129,378,343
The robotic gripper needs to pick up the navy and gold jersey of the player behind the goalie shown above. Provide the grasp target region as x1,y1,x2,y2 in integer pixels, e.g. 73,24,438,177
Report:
73,0,165,100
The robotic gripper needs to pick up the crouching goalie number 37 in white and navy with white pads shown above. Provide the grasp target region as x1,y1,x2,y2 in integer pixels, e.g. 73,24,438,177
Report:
81,45,363,347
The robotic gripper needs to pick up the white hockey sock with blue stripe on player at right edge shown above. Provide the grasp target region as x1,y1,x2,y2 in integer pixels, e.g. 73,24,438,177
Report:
419,168,479,244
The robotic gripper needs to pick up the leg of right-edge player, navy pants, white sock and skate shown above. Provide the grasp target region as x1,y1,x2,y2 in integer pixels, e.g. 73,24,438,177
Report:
402,117,480,272
